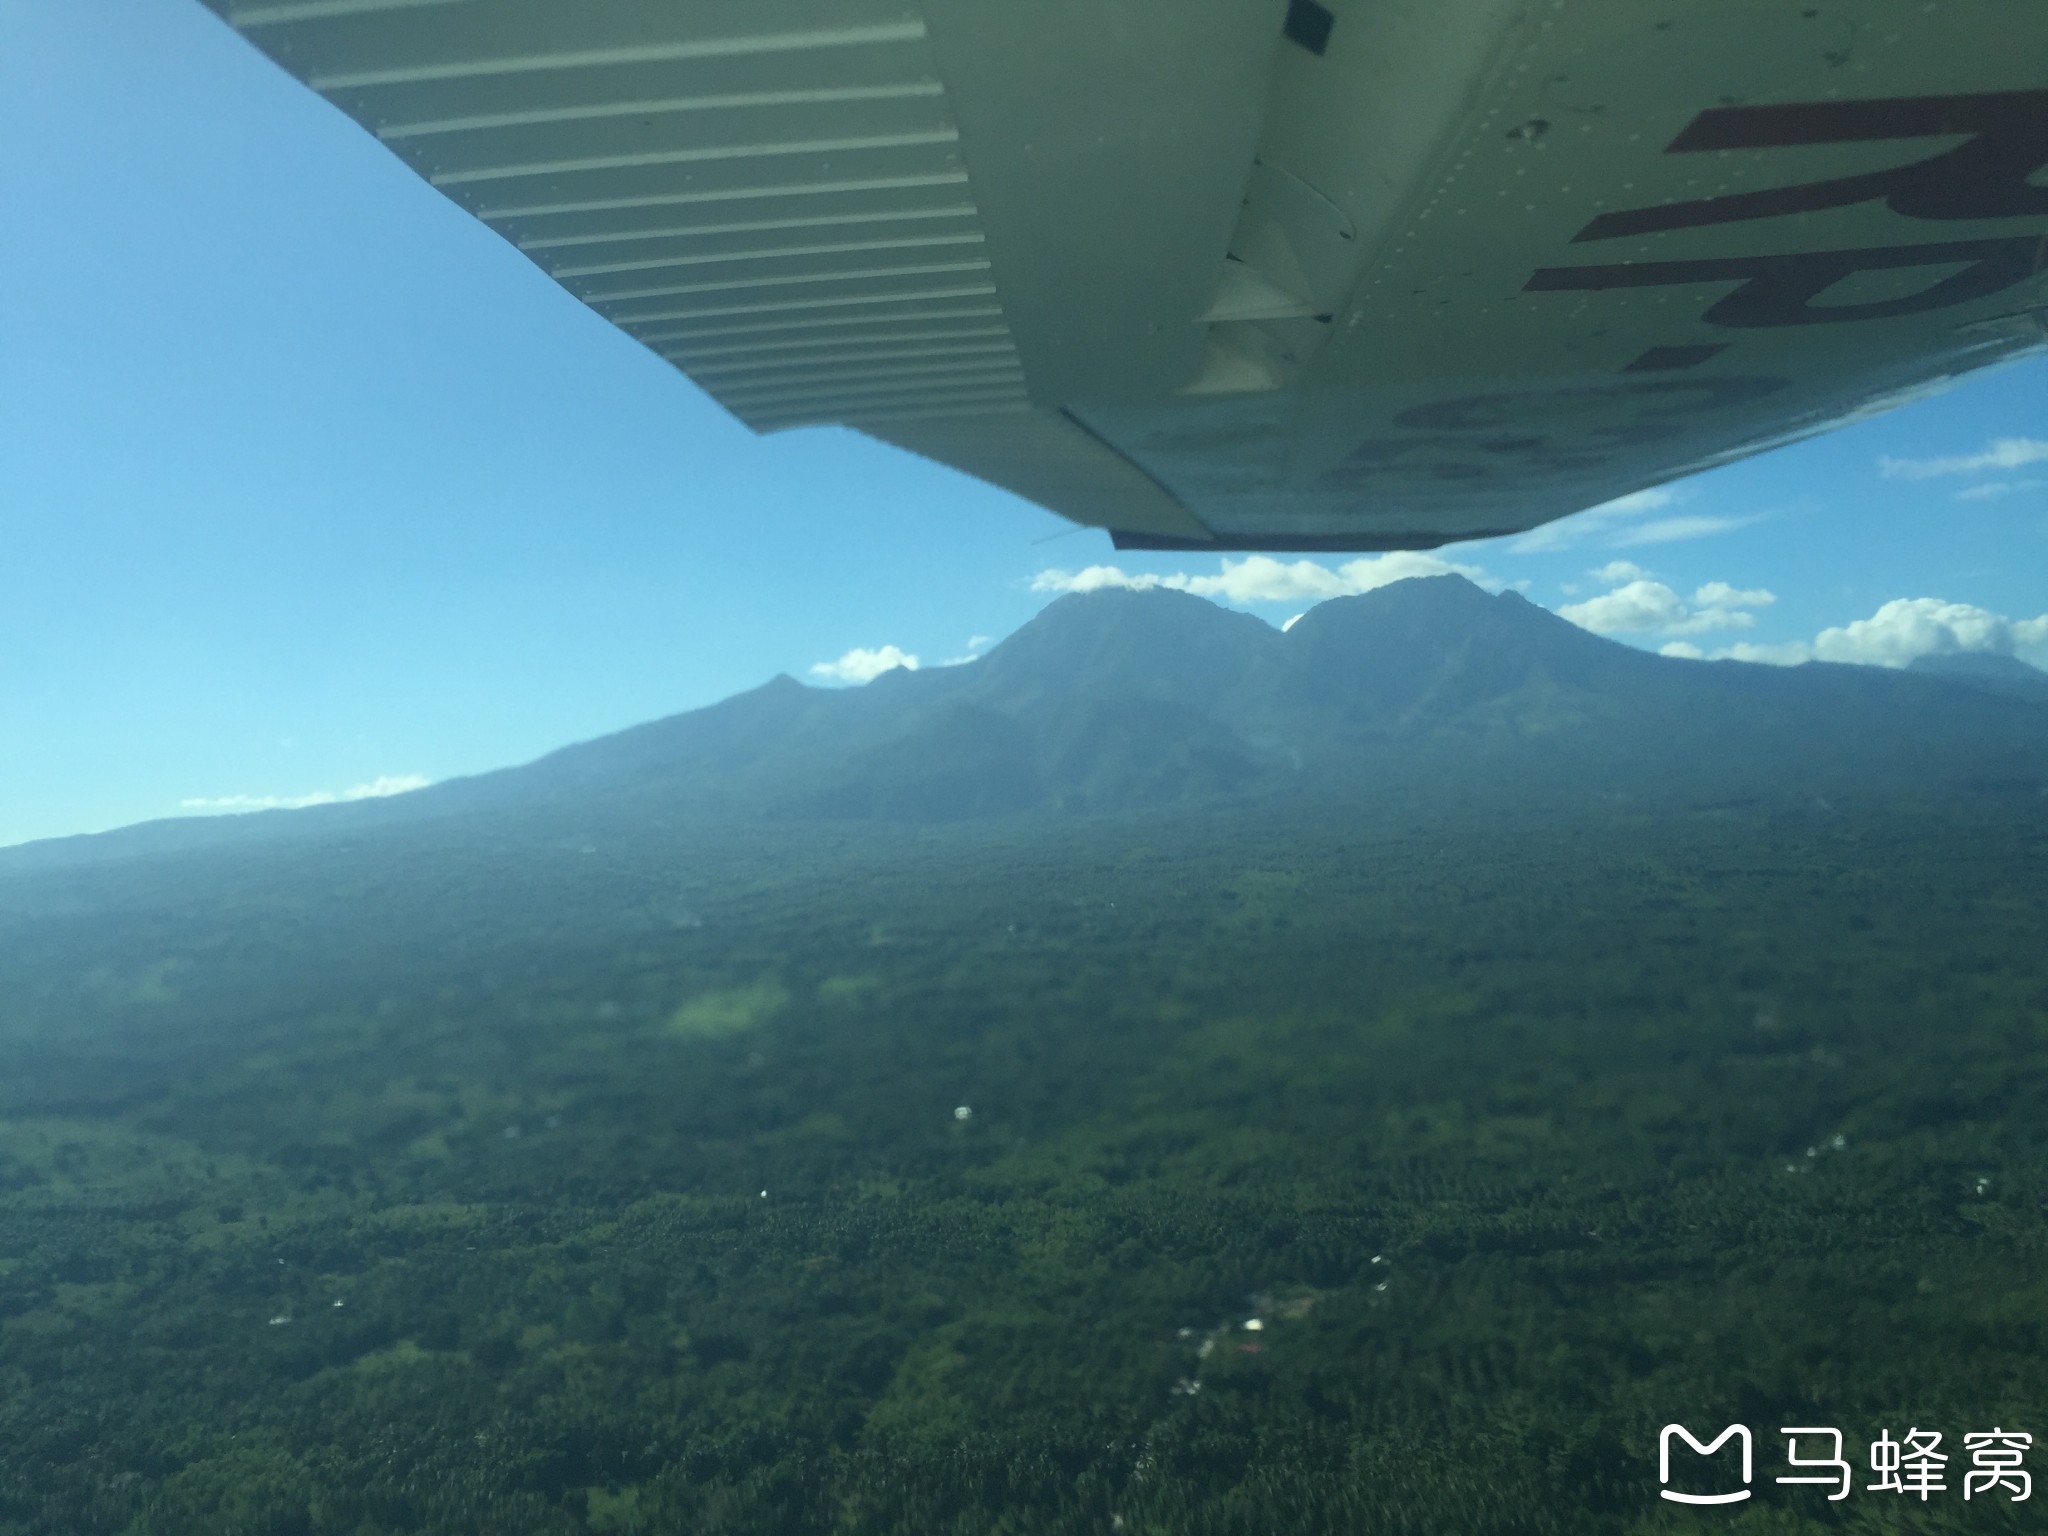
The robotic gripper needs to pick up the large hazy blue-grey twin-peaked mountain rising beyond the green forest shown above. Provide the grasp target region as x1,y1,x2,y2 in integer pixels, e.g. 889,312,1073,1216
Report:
0,575,2048,872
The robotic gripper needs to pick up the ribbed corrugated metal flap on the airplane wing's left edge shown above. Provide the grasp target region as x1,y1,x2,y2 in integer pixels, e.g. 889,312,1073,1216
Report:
215,0,1030,430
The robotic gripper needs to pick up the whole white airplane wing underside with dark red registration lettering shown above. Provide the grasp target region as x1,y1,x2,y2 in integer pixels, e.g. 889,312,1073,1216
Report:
195,0,2048,549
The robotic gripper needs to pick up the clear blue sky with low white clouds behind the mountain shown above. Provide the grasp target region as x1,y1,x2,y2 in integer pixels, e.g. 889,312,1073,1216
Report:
0,0,2048,844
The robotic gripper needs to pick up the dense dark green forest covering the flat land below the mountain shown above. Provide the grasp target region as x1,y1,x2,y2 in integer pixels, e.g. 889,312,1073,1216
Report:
0,788,2048,1536
